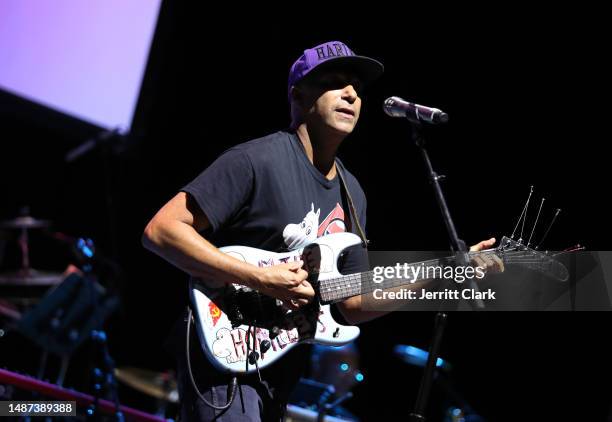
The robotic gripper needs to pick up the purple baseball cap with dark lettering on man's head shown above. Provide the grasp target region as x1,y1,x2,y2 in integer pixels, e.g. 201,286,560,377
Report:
288,41,384,91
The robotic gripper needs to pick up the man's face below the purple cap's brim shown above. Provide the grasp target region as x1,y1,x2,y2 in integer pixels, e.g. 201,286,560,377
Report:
300,71,362,136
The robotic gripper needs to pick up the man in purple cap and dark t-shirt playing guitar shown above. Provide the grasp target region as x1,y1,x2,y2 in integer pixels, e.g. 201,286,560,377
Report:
143,42,494,421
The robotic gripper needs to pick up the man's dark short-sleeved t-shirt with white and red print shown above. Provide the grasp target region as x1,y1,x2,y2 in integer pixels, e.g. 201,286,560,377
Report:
177,131,369,396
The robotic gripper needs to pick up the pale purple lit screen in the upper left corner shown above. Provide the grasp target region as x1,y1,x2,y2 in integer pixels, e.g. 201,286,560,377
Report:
0,0,161,130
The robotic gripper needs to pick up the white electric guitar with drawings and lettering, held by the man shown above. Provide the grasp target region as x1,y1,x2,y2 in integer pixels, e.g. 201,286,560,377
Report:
190,233,568,374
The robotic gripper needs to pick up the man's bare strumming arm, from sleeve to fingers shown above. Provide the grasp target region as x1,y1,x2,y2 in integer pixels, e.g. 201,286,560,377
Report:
142,192,314,308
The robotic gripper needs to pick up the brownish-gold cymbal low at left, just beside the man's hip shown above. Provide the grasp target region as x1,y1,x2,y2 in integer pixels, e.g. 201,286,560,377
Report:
115,366,178,403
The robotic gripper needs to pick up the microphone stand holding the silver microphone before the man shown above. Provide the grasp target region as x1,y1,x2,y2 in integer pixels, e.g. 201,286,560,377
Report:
408,119,484,422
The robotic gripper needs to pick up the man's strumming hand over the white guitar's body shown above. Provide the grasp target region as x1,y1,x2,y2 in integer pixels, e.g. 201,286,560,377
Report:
253,261,315,310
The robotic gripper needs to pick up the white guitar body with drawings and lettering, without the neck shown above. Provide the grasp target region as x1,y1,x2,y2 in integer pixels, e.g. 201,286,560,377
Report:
190,233,361,374
